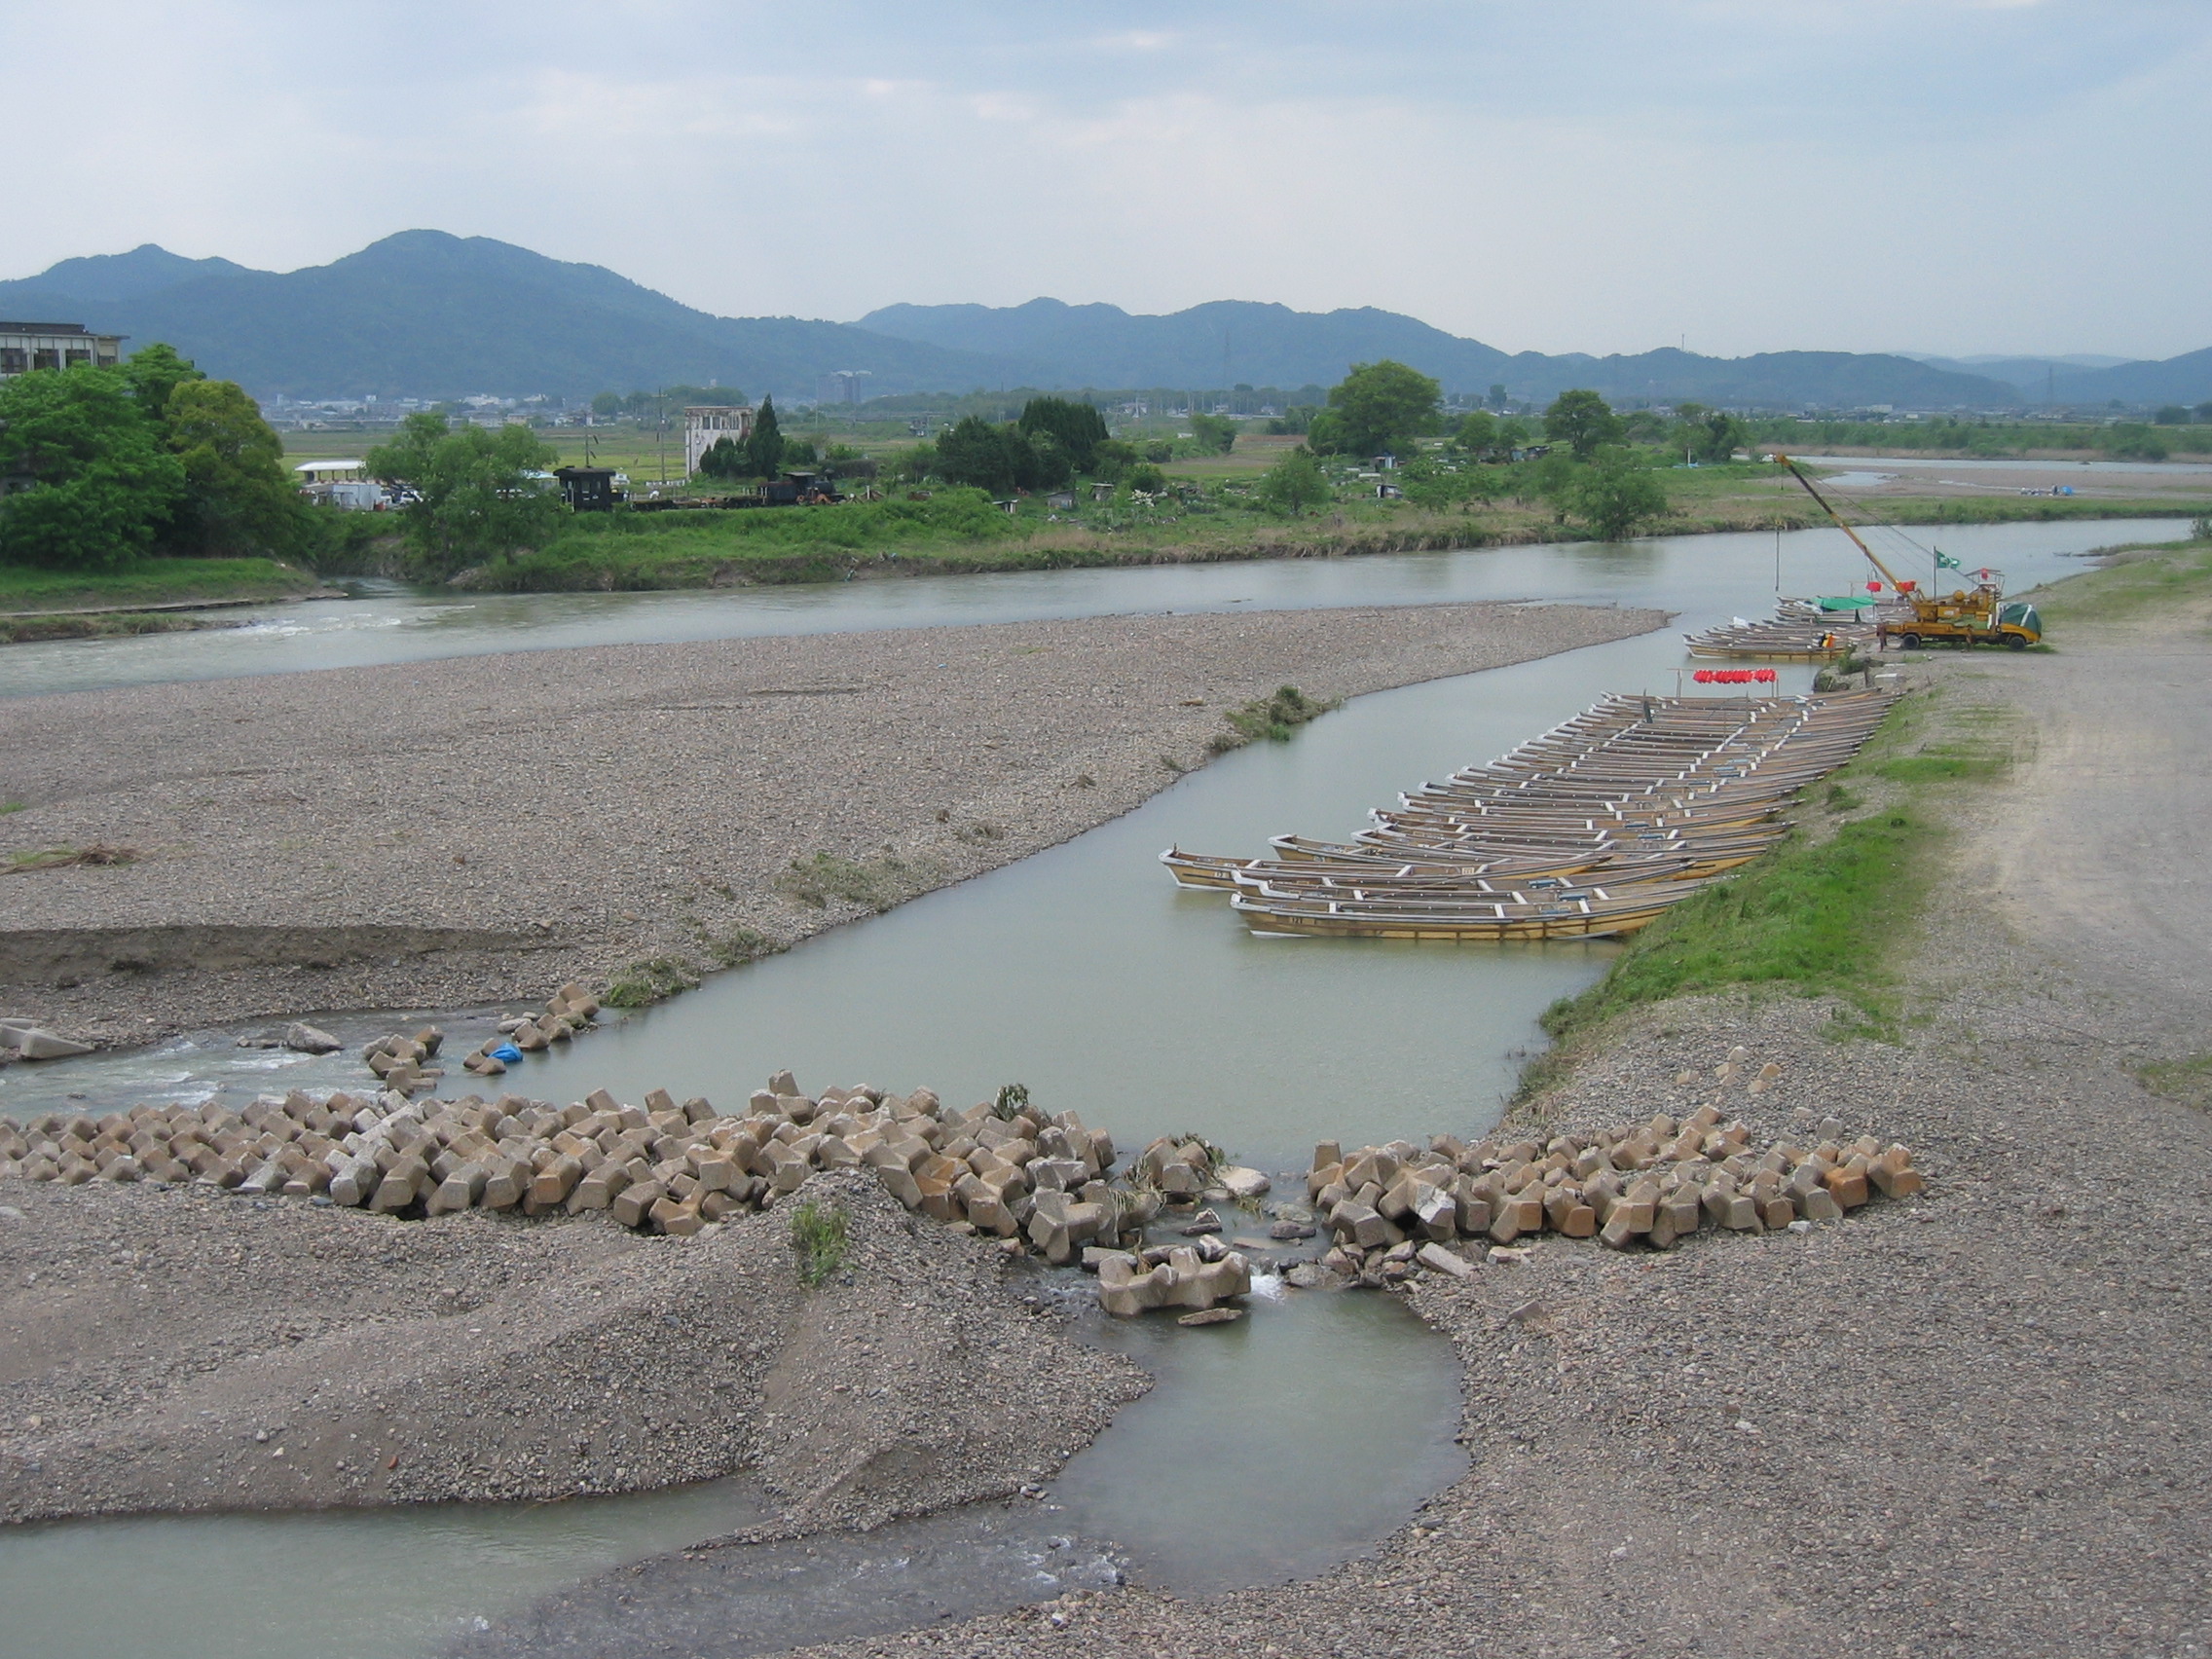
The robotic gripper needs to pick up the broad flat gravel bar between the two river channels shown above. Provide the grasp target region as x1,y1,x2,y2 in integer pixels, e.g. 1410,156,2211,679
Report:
0,604,1666,1042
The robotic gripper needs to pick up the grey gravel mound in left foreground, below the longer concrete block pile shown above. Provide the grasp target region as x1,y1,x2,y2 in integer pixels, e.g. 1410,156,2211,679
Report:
0,1170,1144,1527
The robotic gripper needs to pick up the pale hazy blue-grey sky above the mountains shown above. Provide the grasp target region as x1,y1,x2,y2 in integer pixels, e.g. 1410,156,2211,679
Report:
0,0,2212,356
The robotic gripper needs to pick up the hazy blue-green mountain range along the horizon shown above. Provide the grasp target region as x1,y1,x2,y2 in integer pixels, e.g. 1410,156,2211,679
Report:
0,230,2212,409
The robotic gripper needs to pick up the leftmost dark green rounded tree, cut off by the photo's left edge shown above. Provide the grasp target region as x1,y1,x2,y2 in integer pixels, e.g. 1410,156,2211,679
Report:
0,363,184,571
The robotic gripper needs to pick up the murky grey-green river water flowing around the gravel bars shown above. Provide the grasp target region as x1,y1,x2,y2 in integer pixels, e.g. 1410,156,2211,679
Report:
0,520,2186,1657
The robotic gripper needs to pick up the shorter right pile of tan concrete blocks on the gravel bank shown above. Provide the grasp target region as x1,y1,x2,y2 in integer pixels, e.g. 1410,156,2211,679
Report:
1308,1106,1922,1270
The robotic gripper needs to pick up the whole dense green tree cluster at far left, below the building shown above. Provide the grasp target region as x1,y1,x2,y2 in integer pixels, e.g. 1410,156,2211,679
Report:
0,345,316,571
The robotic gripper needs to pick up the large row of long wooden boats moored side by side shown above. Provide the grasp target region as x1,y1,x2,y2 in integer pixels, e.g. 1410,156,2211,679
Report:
1160,692,1889,940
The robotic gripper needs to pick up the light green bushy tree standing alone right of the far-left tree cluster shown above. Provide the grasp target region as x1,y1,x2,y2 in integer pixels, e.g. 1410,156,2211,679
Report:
367,414,560,575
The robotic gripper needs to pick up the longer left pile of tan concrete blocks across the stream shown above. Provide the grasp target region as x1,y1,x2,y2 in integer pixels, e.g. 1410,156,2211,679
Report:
0,1070,1160,1263
